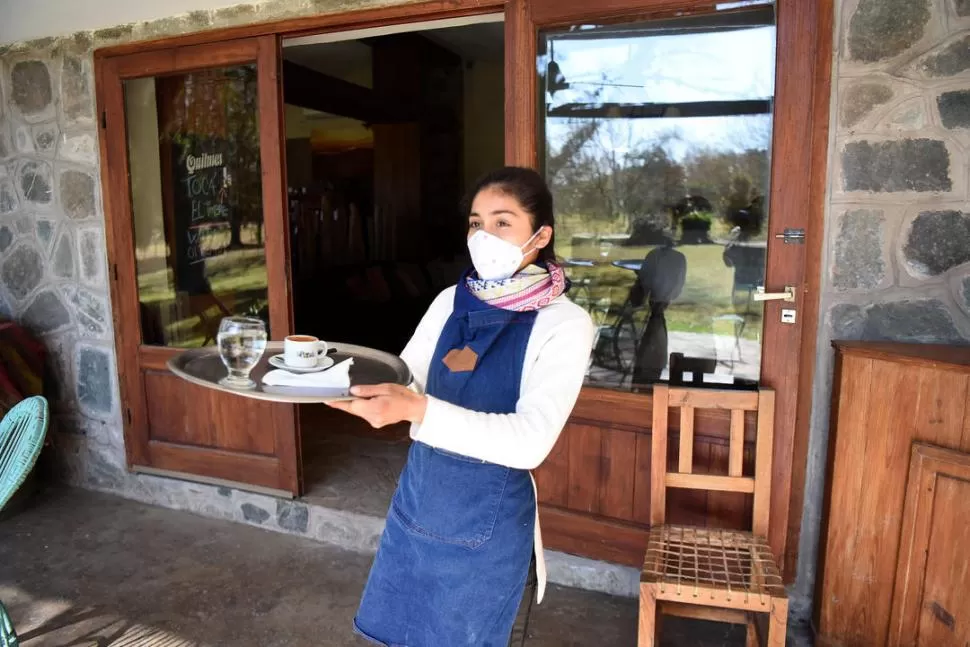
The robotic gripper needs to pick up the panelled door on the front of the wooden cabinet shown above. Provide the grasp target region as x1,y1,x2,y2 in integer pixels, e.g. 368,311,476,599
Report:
887,443,970,647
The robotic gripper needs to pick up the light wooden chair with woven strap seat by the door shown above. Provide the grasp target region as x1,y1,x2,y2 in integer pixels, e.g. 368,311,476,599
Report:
638,385,788,647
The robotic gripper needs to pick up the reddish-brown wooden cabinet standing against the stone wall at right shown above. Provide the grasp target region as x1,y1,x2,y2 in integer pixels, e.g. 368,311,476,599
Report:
815,342,970,647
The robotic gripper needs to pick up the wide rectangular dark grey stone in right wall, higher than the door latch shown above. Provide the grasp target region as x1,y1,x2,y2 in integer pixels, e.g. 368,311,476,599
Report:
842,139,953,192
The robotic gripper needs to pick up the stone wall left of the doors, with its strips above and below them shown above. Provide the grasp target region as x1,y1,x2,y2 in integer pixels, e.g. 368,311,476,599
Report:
0,0,428,568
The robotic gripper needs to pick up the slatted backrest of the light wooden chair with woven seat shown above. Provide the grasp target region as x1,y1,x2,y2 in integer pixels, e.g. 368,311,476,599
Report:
650,385,775,537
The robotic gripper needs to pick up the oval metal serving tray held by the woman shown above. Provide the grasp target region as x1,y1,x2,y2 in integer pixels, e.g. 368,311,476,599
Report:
168,341,411,404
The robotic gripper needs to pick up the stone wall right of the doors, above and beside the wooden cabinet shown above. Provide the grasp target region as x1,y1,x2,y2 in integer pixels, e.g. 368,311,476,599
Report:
796,0,970,616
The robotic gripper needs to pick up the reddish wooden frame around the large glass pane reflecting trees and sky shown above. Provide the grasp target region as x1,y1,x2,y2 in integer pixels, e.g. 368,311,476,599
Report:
505,0,833,580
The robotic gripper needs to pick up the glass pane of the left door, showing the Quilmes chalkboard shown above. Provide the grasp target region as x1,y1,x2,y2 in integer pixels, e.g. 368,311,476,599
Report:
123,62,269,348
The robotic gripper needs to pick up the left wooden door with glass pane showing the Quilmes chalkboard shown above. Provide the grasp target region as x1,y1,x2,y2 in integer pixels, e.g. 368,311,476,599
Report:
97,36,300,495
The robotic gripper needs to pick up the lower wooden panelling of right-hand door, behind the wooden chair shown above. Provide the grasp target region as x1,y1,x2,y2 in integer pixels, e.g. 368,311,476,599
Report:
535,389,756,566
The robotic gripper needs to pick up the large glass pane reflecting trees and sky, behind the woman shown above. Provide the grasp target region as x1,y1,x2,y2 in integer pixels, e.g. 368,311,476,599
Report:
537,6,776,390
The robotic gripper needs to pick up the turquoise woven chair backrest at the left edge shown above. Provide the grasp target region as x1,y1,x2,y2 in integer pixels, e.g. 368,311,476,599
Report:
0,395,48,510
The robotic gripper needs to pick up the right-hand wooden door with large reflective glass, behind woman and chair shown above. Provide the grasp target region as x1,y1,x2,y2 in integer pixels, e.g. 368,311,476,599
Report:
506,0,831,577
